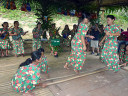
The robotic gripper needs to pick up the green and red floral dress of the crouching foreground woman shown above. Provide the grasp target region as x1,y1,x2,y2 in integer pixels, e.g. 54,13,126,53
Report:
11,64,40,93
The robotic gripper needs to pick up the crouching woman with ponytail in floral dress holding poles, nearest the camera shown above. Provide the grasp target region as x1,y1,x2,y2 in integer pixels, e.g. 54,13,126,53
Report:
11,51,46,96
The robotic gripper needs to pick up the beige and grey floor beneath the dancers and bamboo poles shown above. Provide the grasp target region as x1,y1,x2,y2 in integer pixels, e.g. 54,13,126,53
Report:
0,41,128,96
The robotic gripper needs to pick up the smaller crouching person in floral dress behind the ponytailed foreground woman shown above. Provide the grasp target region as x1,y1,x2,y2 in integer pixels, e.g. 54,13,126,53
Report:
38,48,49,76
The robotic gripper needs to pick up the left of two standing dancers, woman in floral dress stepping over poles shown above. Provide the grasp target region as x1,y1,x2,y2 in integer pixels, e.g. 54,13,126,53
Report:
64,17,94,74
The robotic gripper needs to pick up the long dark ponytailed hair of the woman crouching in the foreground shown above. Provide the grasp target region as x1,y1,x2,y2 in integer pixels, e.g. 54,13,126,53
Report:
19,51,41,68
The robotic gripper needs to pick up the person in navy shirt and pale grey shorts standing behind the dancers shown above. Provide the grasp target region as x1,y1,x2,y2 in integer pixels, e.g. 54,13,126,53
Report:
91,24,100,56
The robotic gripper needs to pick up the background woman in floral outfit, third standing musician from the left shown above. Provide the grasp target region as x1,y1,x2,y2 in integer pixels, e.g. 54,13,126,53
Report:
32,22,43,51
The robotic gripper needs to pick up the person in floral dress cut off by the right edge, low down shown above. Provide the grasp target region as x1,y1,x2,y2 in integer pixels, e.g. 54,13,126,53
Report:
119,44,128,66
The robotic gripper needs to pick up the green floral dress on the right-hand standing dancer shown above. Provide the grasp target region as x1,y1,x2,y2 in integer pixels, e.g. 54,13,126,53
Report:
101,25,121,72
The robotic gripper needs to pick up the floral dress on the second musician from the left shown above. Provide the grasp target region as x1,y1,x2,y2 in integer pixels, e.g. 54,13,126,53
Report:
9,28,24,54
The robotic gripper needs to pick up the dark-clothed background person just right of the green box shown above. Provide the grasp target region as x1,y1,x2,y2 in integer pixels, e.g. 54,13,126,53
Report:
62,25,71,46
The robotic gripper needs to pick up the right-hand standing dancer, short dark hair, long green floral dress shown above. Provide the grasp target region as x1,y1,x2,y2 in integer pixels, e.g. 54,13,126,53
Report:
99,15,121,72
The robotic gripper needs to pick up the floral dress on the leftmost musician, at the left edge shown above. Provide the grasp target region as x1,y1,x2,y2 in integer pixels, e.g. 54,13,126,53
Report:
0,28,11,49
